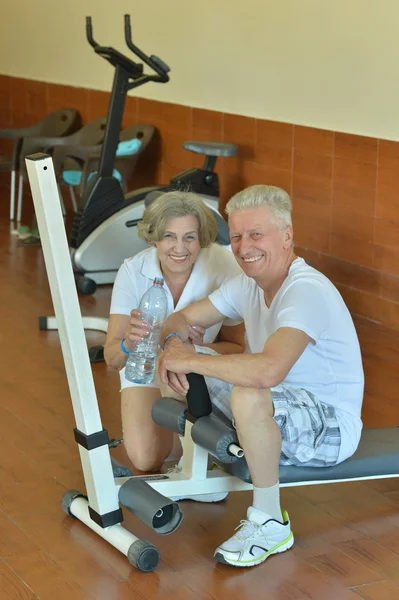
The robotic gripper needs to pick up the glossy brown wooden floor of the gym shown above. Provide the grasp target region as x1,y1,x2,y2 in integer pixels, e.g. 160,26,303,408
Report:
0,191,399,600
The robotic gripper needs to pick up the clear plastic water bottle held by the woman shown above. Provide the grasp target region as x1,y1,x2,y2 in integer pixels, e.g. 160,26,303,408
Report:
125,277,168,384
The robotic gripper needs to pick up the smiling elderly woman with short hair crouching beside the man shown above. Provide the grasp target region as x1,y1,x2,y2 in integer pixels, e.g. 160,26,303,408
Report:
104,192,244,478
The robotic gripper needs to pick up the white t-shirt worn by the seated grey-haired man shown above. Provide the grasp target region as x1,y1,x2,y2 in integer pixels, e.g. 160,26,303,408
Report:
209,258,364,462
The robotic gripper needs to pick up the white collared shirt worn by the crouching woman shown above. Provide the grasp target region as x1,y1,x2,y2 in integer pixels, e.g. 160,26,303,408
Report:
110,244,242,344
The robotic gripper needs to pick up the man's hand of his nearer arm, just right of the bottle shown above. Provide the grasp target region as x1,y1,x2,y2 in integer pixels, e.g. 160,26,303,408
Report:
158,338,197,396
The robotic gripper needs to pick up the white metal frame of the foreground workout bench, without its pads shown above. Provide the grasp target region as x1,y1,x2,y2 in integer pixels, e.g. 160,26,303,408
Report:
26,155,393,572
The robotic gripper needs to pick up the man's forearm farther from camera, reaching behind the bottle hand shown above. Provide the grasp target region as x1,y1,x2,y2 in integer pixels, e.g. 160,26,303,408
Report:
160,298,226,348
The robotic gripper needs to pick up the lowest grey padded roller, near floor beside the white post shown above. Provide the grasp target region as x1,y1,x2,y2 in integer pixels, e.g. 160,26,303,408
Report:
119,477,183,535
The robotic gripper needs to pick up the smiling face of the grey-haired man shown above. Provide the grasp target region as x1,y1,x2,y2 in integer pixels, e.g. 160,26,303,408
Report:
229,206,292,281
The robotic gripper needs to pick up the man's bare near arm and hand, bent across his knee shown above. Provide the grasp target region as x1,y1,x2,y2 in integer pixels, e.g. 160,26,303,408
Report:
159,327,311,394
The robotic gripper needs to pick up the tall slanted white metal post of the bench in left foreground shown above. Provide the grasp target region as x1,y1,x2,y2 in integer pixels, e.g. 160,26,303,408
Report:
26,154,119,515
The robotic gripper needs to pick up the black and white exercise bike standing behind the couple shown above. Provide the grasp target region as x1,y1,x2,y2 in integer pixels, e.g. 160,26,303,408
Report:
70,15,237,294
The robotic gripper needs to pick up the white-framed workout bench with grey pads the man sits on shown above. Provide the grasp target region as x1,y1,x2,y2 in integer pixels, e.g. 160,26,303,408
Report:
26,154,399,571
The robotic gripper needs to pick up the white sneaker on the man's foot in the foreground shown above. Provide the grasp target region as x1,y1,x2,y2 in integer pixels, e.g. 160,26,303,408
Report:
214,506,294,567
